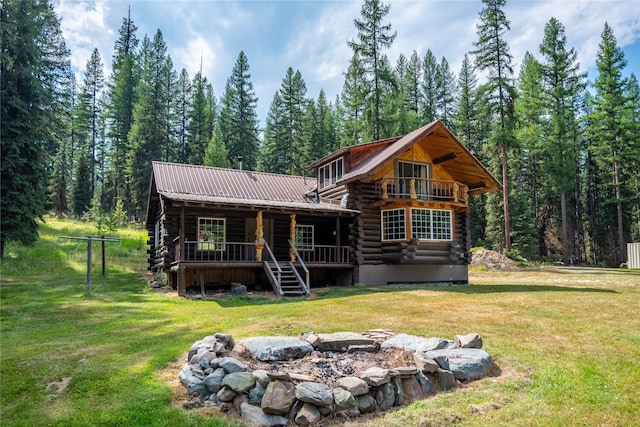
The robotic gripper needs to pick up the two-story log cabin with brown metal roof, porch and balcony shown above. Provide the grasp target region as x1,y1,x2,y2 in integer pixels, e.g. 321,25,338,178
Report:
147,121,500,296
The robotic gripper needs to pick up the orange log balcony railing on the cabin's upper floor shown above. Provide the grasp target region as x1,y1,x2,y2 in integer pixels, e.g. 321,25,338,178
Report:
376,177,469,204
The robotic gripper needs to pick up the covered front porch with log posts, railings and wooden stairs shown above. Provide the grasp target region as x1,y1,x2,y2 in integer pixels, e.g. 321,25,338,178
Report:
169,203,354,296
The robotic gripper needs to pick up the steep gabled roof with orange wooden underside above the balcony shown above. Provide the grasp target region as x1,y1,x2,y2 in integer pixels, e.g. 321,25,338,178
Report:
332,120,501,194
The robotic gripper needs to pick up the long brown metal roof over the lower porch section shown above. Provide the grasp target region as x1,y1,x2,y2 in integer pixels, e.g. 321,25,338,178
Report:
152,162,356,213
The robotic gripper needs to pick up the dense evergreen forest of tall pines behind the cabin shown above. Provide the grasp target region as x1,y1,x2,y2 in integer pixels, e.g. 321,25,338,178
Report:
0,0,640,266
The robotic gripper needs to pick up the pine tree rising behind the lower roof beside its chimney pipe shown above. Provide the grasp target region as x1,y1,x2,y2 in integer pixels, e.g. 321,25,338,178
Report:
219,52,259,170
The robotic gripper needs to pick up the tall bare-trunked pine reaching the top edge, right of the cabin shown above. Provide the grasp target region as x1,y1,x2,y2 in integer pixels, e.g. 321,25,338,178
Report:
473,0,515,251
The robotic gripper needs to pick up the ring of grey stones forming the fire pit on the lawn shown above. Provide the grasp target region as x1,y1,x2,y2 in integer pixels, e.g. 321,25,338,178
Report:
179,329,493,426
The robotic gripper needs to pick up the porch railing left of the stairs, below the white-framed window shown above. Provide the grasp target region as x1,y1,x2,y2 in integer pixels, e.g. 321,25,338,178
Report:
176,240,256,262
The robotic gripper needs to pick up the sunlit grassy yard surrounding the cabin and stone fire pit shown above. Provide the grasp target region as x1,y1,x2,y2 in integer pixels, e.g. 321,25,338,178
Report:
0,218,640,427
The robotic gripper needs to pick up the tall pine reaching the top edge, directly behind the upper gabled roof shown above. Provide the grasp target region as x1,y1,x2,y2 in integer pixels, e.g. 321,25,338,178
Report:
348,0,397,139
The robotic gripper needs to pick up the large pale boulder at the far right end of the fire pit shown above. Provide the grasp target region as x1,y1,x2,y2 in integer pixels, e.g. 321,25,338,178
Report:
426,348,491,380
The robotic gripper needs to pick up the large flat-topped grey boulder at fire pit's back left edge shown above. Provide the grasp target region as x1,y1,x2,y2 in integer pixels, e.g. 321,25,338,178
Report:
240,337,313,362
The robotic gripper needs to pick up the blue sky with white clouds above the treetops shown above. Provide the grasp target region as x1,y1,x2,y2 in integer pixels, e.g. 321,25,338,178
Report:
54,0,640,122
